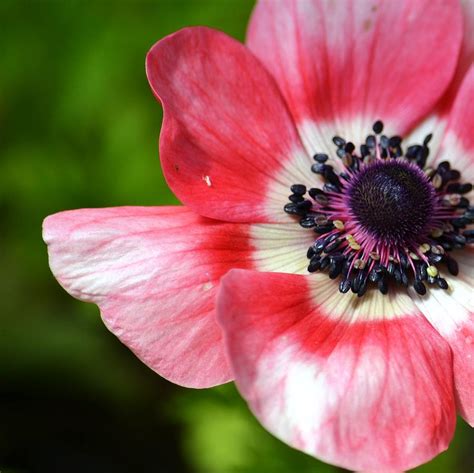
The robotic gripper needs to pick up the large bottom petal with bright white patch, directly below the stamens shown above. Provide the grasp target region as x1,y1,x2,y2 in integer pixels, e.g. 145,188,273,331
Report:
218,270,456,473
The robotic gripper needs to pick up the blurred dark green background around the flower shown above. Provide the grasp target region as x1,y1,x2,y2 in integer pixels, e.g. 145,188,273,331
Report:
0,0,474,473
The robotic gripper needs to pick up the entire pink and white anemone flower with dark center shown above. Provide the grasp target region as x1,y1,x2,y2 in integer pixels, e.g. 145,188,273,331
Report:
44,0,474,472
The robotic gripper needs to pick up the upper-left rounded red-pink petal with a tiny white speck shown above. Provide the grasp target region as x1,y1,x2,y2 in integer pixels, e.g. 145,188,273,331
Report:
146,27,311,223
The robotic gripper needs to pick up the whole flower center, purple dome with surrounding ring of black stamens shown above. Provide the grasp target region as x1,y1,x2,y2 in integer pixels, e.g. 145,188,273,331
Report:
284,121,474,297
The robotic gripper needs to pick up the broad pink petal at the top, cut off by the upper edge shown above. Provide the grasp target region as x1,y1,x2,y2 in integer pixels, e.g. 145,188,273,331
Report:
247,0,462,159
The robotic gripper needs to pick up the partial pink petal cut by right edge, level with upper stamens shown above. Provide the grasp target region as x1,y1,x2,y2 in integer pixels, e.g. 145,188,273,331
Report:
433,65,474,183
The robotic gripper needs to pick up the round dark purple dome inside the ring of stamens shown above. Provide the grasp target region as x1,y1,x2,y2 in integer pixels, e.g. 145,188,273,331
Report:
348,160,436,245
